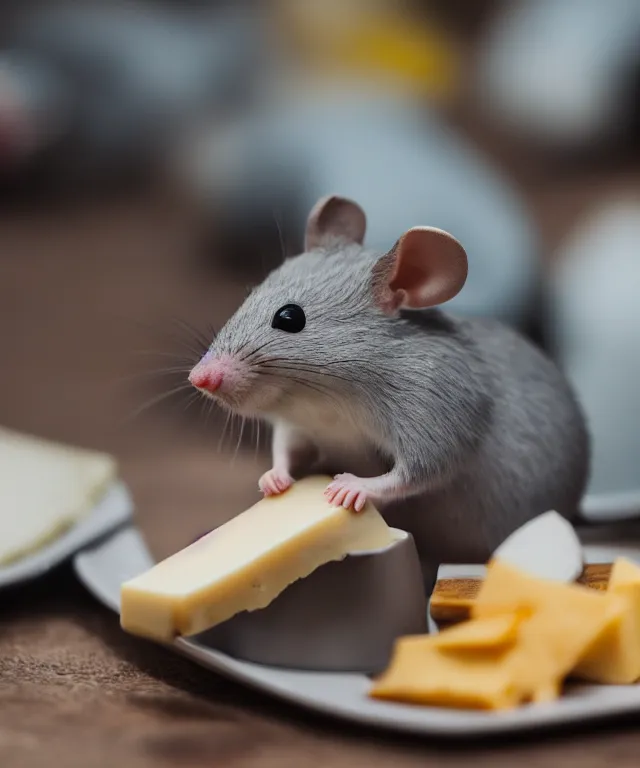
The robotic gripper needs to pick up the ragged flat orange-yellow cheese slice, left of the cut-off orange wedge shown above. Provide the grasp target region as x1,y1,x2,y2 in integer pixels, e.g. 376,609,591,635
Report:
370,559,624,709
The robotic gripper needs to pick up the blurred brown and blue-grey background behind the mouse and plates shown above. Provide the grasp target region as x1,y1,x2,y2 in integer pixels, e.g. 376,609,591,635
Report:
0,0,640,556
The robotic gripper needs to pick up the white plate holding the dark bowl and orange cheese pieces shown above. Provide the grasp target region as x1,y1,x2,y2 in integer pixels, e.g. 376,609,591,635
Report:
74,525,640,739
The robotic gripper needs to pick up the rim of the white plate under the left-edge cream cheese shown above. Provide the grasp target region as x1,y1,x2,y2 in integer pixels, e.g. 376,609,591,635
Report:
0,482,133,589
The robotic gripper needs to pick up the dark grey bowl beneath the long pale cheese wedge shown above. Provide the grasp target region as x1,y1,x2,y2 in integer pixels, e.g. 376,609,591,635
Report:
198,529,427,673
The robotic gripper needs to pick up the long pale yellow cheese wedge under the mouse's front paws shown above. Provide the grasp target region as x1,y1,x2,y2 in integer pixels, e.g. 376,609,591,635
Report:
120,477,393,642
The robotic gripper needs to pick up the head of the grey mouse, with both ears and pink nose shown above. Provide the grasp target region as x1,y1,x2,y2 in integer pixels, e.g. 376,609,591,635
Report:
189,196,467,415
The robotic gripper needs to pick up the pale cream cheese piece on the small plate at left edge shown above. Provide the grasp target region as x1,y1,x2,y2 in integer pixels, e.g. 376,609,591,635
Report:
0,427,117,565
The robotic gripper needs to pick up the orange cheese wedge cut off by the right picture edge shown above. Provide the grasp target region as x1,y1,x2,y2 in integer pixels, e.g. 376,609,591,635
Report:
574,557,640,685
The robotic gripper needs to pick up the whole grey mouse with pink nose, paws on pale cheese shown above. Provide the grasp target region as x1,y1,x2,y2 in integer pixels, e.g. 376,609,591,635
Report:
189,196,590,563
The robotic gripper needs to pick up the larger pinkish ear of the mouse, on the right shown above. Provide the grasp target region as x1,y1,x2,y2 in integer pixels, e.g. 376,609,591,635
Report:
373,227,468,314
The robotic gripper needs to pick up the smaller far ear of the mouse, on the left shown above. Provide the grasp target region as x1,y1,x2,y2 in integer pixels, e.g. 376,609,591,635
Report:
304,195,367,251
